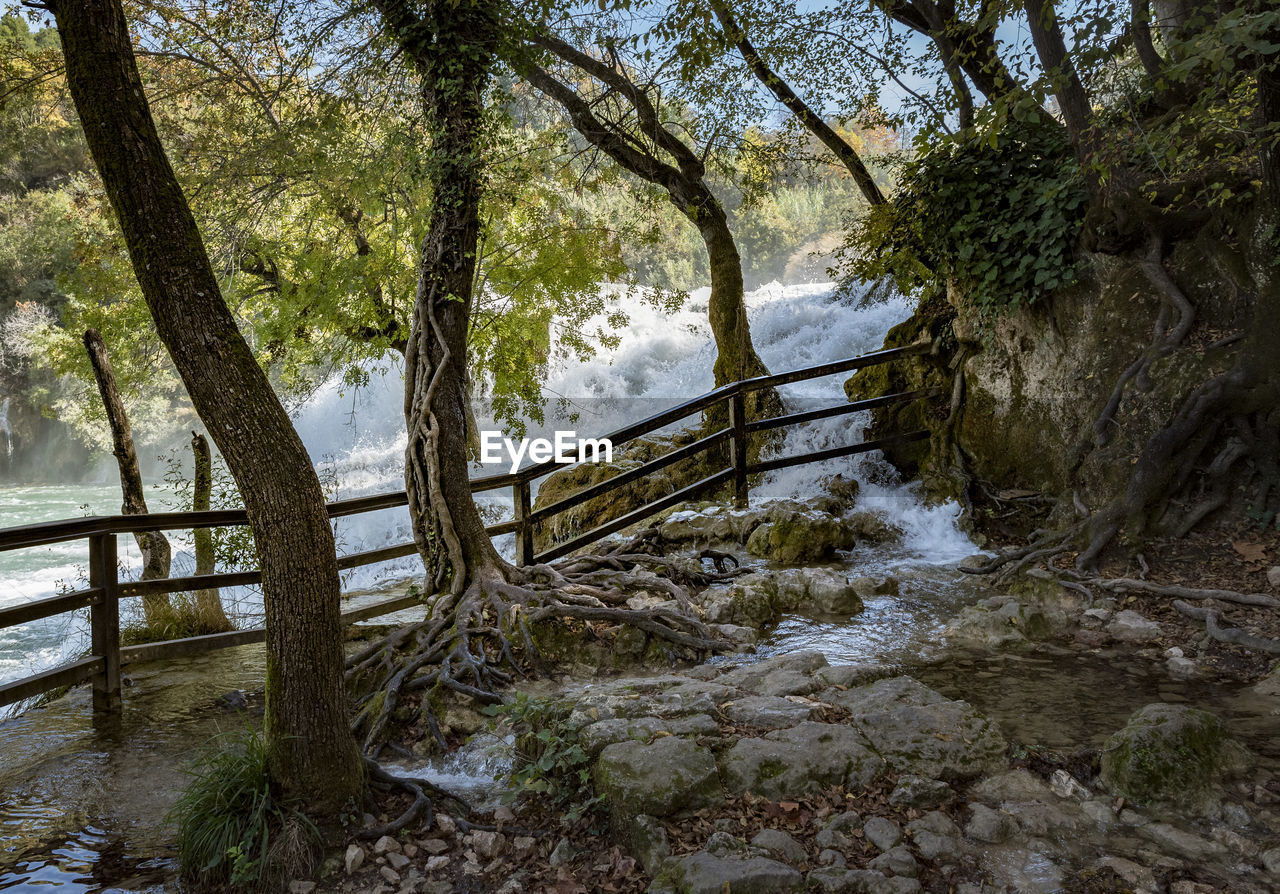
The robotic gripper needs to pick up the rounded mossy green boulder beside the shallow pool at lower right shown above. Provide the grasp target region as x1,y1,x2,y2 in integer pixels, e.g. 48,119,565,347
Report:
1102,703,1248,806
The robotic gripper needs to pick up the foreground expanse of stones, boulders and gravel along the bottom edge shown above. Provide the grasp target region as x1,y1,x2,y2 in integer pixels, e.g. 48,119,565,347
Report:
317,653,1280,894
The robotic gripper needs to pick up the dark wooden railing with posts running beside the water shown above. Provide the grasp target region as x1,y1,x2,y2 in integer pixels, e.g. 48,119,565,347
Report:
0,342,938,712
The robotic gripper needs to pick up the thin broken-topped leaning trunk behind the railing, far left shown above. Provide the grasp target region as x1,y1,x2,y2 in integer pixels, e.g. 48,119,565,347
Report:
84,329,173,630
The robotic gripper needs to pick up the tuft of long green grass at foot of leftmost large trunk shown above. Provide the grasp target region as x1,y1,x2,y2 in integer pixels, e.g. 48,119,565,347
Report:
170,731,320,891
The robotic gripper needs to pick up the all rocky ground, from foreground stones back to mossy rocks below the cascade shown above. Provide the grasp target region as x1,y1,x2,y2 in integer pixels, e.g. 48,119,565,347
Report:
309,483,1280,894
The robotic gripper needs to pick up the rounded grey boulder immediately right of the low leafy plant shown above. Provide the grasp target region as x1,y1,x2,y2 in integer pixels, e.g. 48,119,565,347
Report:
593,736,724,829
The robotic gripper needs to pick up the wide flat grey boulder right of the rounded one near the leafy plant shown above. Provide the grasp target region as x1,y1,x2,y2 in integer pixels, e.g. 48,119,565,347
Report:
721,721,884,801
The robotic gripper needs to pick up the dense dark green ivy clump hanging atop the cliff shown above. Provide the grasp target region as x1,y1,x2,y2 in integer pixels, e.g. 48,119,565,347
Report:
844,124,1087,311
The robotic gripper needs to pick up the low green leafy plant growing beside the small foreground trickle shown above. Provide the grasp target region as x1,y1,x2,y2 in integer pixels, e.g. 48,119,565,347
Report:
485,693,600,824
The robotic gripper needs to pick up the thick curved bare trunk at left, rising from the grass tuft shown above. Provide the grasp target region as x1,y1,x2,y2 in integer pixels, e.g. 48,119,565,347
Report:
49,0,364,813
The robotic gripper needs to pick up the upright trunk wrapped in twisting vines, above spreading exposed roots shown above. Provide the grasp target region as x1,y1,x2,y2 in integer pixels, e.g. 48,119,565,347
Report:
378,0,506,596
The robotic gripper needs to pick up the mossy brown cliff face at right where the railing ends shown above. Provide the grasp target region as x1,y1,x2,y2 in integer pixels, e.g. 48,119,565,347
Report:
846,222,1276,520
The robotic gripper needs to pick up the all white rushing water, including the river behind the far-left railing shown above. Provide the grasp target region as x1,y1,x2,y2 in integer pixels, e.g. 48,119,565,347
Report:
0,284,973,680
